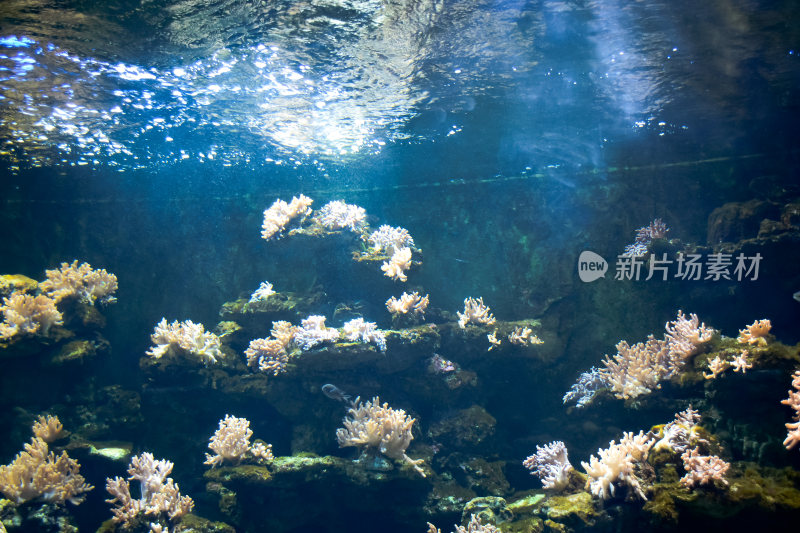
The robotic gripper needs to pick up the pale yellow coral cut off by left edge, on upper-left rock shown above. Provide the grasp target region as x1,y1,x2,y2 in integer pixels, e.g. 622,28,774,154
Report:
0,292,63,339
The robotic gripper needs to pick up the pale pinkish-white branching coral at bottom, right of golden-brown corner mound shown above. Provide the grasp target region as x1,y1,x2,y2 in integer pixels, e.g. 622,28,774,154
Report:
106,452,194,528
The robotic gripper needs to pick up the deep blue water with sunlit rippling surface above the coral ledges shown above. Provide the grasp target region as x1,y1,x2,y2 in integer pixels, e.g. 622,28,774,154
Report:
0,0,800,531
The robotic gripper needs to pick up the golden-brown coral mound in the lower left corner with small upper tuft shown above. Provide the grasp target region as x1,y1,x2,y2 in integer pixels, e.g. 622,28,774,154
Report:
0,417,94,505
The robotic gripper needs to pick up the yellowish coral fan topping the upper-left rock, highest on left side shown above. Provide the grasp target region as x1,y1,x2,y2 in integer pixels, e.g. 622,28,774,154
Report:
39,259,118,305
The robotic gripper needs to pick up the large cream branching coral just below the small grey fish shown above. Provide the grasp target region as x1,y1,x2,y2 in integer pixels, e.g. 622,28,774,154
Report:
336,396,425,477
